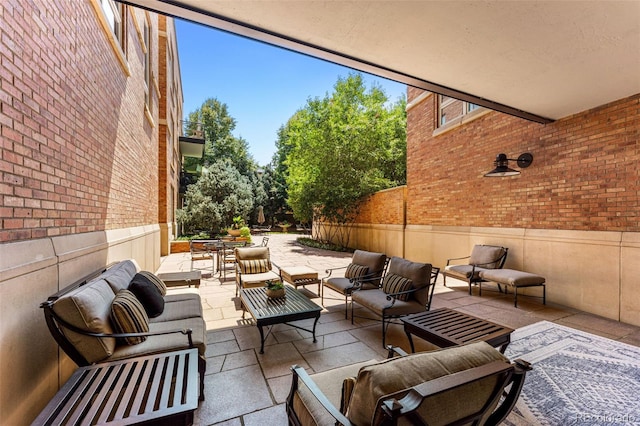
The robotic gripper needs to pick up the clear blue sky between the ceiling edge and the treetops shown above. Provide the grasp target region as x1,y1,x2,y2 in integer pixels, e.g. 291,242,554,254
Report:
176,19,406,165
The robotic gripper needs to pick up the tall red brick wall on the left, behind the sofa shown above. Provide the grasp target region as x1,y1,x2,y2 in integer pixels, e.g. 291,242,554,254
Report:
0,0,158,242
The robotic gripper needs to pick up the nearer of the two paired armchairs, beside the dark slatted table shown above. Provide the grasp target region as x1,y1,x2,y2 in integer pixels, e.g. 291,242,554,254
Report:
351,257,440,347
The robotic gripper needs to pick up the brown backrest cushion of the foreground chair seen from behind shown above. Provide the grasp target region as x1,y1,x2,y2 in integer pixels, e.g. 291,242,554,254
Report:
346,342,508,425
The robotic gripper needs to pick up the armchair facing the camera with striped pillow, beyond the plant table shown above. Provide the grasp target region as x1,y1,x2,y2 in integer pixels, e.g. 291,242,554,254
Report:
235,247,280,296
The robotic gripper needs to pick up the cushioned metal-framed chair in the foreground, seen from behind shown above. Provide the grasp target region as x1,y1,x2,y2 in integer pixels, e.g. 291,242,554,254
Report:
286,342,531,426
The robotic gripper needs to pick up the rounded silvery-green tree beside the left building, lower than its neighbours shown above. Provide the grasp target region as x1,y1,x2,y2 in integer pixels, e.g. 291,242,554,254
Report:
181,161,253,233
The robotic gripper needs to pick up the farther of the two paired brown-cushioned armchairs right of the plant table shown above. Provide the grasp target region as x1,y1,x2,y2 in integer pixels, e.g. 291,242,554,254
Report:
321,250,388,319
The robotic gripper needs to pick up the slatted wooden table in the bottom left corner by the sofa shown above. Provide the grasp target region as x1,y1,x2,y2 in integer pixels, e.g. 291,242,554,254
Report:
32,349,199,425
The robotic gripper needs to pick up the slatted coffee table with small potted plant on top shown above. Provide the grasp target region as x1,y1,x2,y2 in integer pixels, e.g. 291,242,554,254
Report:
240,285,322,354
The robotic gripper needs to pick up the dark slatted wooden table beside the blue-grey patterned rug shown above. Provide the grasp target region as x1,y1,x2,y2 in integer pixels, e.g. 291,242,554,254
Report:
402,308,513,353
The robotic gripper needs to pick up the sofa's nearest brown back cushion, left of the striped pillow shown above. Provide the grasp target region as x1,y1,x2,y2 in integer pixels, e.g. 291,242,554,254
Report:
53,278,116,363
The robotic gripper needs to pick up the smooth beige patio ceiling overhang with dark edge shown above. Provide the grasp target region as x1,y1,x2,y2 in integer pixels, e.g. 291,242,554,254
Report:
125,0,640,123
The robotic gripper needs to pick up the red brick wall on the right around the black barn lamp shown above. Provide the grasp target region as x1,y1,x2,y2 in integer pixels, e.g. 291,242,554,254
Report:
407,89,640,232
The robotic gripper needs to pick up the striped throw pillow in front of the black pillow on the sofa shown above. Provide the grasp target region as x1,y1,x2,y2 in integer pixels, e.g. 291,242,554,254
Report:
111,290,149,345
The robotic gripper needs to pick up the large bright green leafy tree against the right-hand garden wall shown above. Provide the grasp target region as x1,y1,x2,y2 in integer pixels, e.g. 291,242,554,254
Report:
278,74,406,246
